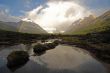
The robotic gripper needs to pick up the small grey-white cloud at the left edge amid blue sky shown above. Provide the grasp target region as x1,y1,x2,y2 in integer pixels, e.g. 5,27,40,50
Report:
0,9,21,22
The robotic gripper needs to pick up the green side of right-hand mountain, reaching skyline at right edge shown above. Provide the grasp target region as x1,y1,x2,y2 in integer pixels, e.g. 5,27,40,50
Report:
69,11,110,35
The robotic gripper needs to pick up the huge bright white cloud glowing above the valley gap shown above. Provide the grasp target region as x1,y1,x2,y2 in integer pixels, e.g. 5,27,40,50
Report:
25,0,91,32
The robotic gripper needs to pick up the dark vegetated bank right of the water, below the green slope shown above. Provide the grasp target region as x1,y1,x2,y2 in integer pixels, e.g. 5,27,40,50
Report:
62,30,110,63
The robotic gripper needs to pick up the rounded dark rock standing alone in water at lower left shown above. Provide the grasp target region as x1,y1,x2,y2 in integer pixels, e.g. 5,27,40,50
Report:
7,51,29,71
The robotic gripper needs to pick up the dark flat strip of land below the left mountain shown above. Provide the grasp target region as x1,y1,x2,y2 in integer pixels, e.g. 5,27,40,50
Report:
0,30,54,46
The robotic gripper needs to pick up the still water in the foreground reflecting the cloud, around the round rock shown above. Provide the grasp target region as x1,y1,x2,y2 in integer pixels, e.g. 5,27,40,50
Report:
0,44,106,73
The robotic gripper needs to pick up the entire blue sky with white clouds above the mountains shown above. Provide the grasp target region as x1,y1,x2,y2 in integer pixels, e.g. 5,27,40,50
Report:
0,0,110,32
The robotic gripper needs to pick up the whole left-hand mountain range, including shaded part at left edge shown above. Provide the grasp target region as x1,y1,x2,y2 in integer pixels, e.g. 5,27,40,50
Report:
0,21,47,34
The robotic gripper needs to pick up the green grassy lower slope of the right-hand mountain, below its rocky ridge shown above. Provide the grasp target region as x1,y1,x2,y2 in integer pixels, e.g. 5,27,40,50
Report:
70,18,110,35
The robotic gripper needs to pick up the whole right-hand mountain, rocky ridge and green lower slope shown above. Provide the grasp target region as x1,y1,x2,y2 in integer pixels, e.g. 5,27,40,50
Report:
65,11,110,34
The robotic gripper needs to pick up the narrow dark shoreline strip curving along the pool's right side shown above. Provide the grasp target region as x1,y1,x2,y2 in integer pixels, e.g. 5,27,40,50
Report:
60,41,110,73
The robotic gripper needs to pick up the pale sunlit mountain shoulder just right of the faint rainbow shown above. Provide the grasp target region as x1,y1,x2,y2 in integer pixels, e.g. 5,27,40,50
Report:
18,21,47,34
